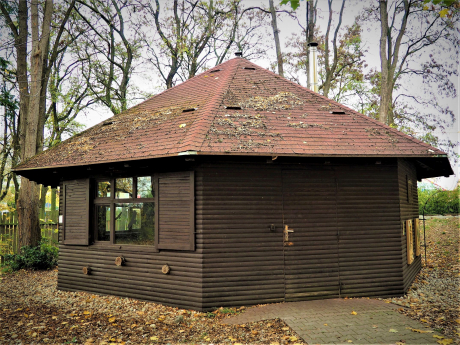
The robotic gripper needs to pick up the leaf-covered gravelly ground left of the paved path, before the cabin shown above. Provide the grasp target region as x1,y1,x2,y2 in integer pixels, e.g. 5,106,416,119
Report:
0,270,305,345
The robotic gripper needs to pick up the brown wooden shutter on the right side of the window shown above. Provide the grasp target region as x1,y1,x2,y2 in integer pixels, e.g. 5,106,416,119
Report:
155,171,195,250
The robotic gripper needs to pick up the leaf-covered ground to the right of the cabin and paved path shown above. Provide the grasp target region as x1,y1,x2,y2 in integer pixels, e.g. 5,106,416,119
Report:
388,217,460,344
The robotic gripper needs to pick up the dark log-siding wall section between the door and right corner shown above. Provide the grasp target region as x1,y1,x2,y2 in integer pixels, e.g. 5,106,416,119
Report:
336,162,403,297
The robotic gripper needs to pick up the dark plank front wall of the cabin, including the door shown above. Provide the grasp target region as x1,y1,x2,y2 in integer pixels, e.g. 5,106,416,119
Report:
197,160,403,308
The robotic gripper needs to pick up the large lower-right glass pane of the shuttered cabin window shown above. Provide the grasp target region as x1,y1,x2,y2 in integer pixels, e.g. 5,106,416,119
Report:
115,202,155,245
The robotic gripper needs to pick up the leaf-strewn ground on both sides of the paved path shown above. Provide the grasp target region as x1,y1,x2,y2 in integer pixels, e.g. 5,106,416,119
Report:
0,218,460,345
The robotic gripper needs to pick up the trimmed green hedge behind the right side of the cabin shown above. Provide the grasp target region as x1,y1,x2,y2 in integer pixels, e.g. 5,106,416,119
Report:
418,188,460,214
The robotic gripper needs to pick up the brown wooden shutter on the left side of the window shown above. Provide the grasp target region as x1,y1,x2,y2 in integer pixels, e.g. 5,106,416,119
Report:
63,179,89,246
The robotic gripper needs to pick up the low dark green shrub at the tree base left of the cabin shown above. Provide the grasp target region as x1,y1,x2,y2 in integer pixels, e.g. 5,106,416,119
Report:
4,241,58,271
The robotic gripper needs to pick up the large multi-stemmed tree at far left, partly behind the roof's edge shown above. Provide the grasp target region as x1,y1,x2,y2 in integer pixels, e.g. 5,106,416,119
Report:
0,0,75,246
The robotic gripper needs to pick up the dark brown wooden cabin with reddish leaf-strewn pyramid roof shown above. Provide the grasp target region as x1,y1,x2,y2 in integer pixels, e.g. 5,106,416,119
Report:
15,58,452,310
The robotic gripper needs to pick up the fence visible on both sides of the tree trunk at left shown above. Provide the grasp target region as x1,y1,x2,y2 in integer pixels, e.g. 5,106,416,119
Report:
0,211,59,257
